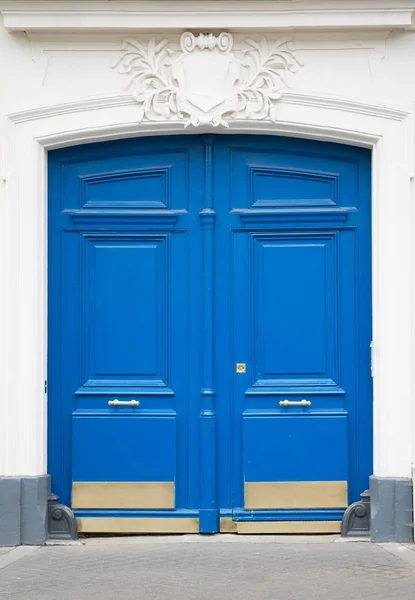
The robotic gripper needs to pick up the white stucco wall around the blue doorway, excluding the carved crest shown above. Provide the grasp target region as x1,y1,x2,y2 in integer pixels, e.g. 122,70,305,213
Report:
0,0,415,506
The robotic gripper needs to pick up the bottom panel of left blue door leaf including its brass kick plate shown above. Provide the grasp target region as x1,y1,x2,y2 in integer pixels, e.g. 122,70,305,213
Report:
72,410,176,509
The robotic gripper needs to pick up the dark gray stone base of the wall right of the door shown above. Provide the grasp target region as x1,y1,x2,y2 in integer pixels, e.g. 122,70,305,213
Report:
370,475,414,542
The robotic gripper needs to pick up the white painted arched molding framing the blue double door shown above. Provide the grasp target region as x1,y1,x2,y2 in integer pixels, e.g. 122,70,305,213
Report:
0,93,414,486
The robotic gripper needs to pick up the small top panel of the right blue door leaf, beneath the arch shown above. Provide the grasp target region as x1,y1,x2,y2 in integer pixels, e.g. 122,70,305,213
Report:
229,144,362,209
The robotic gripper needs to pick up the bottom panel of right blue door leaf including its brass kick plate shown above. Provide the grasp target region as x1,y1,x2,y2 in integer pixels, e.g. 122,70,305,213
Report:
243,412,348,510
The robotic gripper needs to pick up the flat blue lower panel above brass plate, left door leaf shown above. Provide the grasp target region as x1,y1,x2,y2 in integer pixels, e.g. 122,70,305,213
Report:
72,408,176,482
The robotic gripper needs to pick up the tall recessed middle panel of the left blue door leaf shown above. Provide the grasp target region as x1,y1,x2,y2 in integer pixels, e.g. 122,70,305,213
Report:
84,235,169,385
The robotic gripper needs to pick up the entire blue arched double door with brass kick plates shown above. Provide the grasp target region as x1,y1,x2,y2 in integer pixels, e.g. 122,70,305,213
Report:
48,135,372,533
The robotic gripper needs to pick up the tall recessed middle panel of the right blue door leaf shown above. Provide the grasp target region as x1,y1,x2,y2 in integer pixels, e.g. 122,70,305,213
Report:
250,233,337,386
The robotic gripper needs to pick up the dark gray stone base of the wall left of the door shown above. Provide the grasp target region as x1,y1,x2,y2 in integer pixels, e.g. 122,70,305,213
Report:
0,475,50,546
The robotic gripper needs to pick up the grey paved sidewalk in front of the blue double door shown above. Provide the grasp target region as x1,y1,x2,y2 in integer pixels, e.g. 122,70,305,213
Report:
0,535,415,600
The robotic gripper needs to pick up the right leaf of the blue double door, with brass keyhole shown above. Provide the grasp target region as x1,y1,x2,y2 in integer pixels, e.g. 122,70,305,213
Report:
215,136,372,519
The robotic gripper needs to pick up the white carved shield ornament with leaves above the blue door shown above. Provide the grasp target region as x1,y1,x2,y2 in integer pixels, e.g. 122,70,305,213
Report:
112,32,301,127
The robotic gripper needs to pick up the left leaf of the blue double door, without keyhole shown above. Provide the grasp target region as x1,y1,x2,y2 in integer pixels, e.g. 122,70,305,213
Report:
48,137,203,512
